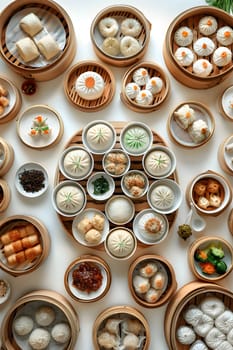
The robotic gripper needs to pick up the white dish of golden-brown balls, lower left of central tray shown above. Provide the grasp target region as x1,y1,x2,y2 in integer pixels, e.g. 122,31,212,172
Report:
72,208,109,247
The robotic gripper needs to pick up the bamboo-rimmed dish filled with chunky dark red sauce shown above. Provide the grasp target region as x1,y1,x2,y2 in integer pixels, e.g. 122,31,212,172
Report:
64,255,111,303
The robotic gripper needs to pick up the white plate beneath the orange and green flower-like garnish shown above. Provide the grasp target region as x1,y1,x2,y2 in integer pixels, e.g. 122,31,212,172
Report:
17,105,63,149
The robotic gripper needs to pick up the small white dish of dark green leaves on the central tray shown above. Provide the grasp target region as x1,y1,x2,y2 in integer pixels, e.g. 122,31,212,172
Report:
86,171,115,201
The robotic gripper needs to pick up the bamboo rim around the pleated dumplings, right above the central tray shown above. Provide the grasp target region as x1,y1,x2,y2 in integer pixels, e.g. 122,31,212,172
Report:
167,101,215,149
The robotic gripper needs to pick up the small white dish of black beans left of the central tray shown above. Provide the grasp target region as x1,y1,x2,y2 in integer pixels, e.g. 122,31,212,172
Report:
15,162,49,198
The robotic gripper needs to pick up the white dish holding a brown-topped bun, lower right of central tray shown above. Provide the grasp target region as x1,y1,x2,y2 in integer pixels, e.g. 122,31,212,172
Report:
133,208,169,245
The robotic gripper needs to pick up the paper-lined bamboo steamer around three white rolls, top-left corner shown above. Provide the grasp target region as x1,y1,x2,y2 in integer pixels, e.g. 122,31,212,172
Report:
0,0,76,81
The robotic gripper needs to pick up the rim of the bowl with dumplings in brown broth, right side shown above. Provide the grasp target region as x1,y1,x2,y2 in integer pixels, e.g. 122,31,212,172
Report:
186,170,232,216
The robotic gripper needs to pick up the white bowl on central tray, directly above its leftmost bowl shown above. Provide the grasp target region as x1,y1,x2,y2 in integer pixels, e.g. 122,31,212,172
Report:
59,146,94,180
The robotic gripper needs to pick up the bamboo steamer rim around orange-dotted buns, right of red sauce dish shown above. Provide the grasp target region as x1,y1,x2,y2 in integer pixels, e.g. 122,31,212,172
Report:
128,254,177,308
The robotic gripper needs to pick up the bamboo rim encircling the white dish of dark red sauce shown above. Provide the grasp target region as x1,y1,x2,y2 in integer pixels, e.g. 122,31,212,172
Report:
64,254,111,303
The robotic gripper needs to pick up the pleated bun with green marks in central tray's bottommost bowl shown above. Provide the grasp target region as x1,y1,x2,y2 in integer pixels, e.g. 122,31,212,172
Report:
106,228,135,258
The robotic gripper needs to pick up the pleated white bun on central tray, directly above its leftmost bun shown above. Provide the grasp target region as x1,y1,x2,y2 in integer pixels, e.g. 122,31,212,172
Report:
63,149,91,178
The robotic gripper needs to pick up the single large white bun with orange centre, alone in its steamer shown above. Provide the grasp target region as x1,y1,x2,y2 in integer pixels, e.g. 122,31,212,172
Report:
75,71,105,100
